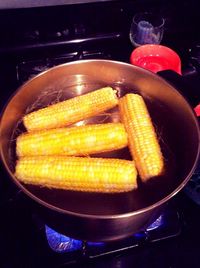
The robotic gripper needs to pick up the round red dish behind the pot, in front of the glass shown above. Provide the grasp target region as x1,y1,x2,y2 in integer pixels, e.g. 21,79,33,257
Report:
130,45,181,74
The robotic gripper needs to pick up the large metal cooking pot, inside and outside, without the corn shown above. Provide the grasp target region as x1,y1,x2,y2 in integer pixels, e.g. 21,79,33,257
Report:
0,60,199,241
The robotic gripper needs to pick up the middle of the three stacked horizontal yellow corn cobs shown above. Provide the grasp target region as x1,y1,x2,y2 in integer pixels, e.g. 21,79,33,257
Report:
16,123,128,157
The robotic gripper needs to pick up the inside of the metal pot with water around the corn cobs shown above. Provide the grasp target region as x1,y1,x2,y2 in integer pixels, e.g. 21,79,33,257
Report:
1,60,199,215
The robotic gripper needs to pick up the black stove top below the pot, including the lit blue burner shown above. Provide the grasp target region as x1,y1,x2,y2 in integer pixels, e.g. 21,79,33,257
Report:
0,184,200,267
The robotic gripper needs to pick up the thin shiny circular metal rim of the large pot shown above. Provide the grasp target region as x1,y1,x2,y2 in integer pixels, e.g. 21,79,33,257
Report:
0,59,200,220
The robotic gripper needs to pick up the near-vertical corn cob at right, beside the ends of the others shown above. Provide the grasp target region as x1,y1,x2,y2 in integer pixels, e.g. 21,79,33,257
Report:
119,94,164,181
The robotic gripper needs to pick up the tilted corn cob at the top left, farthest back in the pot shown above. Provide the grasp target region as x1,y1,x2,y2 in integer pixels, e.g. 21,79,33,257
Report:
23,87,118,131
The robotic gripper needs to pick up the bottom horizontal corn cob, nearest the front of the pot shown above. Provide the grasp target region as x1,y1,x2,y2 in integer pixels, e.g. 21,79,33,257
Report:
15,156,137,193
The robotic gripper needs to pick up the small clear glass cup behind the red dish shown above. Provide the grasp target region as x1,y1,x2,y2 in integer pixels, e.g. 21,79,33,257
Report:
129,12,165,47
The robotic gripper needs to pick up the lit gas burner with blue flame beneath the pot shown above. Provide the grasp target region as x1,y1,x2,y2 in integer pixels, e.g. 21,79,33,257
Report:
43,206,183,259
